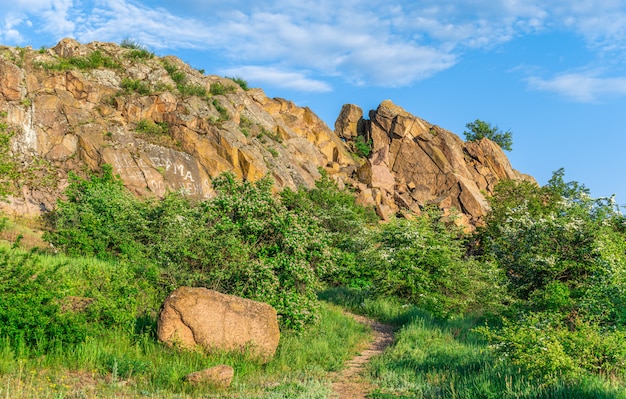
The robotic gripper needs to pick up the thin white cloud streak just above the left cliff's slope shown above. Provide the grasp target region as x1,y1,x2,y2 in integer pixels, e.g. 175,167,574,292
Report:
220,66,332,92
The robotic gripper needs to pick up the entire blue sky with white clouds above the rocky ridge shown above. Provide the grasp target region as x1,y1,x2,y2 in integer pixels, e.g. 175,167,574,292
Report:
0,0,626,204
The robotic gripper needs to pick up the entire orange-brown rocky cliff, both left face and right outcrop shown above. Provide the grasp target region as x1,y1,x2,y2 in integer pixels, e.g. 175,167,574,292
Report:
0,39,529,225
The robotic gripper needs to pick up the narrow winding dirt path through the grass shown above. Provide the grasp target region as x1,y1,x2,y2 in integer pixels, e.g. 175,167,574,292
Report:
333,314,393,399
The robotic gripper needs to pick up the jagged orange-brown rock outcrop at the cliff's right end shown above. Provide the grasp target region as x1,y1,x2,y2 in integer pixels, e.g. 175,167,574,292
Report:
335,101,533,226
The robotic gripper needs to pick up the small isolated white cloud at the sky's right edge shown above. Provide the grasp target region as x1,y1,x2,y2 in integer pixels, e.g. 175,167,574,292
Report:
528,71,626,102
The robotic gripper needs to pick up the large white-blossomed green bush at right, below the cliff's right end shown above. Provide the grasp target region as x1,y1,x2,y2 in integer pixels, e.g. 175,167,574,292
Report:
479,170,626,323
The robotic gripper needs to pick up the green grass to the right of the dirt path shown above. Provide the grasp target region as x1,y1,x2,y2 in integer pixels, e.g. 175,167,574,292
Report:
321,289,626,399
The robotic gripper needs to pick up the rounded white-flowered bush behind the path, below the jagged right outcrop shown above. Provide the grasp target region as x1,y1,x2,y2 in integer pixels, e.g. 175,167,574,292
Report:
364,209,503,317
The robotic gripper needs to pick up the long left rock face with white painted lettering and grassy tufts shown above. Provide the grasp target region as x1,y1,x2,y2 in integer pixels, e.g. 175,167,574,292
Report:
0,39,355,215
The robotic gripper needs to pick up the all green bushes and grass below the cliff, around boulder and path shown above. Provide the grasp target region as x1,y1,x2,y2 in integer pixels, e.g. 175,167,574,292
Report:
0,166,626,398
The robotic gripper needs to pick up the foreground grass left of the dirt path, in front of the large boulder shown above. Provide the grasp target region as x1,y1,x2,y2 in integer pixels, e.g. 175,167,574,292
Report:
0,305,369,398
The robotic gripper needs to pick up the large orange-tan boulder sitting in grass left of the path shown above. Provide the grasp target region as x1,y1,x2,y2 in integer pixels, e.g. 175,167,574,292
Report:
157,287,280,361
